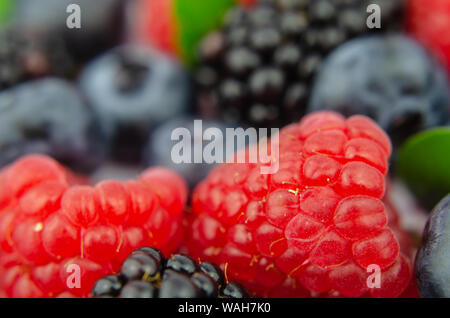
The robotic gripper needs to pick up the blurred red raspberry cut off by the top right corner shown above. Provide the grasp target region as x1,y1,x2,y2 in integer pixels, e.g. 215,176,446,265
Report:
408,0,450,71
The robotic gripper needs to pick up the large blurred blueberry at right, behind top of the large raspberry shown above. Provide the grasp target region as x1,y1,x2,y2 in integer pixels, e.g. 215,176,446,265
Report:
309,35,449,146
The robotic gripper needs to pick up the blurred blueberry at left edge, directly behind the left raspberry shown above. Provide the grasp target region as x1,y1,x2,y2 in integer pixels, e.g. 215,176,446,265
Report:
0,78,107,172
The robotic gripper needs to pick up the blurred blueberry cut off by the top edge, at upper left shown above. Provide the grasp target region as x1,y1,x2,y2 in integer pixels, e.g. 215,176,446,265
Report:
15,0,126,62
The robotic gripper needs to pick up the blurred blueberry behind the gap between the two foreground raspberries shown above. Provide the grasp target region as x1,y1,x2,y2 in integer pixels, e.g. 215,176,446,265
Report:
144,116,250,188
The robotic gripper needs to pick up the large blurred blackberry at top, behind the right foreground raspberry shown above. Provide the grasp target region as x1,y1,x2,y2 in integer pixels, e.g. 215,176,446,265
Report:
195,0,404,127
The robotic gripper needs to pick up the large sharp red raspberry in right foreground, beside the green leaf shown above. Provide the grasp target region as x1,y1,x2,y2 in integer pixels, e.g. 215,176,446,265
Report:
186,112,411,297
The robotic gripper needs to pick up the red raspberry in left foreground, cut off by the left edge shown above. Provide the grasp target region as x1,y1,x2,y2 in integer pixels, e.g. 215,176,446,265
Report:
0,155,187,297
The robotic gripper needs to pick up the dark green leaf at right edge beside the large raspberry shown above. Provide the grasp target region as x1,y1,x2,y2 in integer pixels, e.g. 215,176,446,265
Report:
396,127,450,209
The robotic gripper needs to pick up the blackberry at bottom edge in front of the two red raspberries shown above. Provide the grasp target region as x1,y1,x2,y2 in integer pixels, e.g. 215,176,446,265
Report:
91,247,249,298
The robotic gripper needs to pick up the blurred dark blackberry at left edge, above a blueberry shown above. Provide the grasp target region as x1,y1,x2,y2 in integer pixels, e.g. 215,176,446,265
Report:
0,26,74,90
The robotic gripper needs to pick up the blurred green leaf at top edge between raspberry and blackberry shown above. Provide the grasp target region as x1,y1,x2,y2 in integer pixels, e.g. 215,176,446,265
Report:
173,0,236,64
